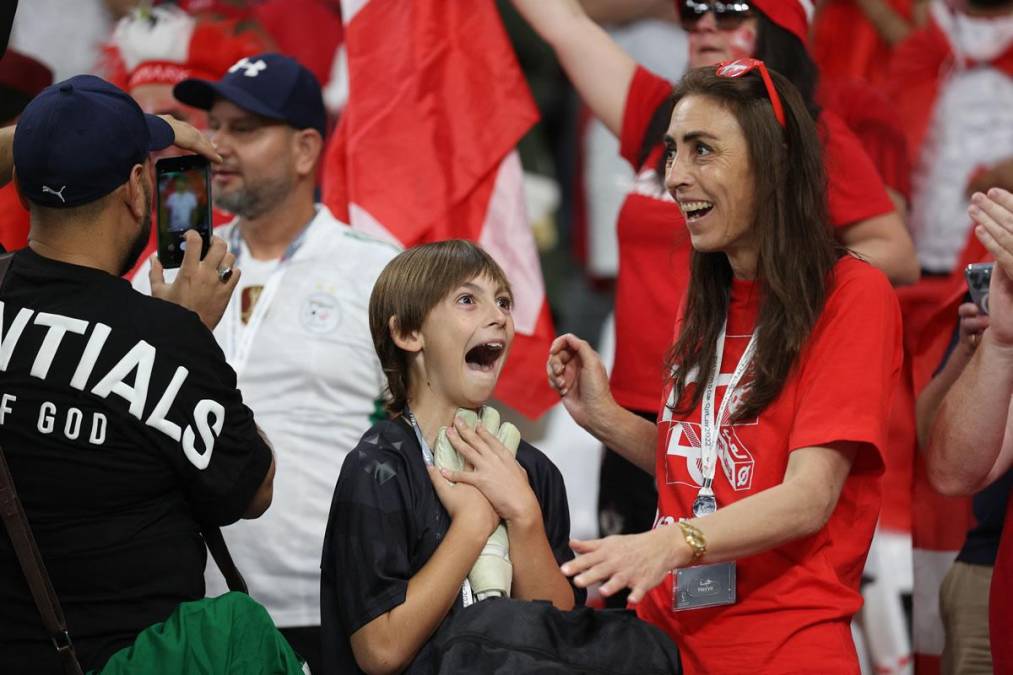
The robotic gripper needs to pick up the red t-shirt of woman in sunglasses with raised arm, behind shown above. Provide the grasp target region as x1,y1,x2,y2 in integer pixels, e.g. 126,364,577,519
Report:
612,68,893,410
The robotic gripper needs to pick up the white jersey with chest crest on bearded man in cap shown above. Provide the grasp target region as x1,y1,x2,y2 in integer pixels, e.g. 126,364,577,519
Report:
134,206,398,626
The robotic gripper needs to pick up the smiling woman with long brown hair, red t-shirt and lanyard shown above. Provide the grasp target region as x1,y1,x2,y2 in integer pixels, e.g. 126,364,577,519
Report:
547,59,901,675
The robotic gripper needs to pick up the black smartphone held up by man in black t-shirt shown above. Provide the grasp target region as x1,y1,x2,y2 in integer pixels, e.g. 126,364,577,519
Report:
155,155,211,269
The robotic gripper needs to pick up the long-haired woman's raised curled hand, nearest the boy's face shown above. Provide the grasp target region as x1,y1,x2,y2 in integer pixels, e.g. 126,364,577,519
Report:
545,333,616,429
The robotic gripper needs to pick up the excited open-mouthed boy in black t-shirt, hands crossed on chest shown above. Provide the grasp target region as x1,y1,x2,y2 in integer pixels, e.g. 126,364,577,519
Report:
320,240,583,673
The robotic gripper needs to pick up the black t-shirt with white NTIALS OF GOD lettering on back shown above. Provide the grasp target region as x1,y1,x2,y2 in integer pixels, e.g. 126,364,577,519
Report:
0,249,270,673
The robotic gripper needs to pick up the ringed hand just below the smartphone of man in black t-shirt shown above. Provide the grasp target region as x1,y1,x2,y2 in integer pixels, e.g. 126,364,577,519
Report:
148,230,241,330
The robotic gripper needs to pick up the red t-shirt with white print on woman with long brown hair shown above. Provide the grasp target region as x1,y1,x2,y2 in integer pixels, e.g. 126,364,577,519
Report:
637,256,902,675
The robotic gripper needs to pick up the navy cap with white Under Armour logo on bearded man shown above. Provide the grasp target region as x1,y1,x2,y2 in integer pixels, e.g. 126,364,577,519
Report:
172,54,327,136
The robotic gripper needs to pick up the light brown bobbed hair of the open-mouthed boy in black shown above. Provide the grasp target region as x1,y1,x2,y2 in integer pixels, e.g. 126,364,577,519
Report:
370,239,510,415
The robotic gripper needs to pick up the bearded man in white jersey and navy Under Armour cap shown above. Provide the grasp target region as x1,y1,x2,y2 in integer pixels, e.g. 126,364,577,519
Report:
134,54,397,671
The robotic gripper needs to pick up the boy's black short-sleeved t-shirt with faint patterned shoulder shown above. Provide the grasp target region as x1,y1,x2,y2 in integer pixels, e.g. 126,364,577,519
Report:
320,418,585,675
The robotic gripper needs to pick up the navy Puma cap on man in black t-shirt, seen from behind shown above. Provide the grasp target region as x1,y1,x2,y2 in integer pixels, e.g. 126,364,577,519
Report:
14,75,175,209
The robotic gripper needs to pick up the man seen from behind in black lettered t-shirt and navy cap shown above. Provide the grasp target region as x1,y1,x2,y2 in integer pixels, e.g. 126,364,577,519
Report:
0,75,274,673
